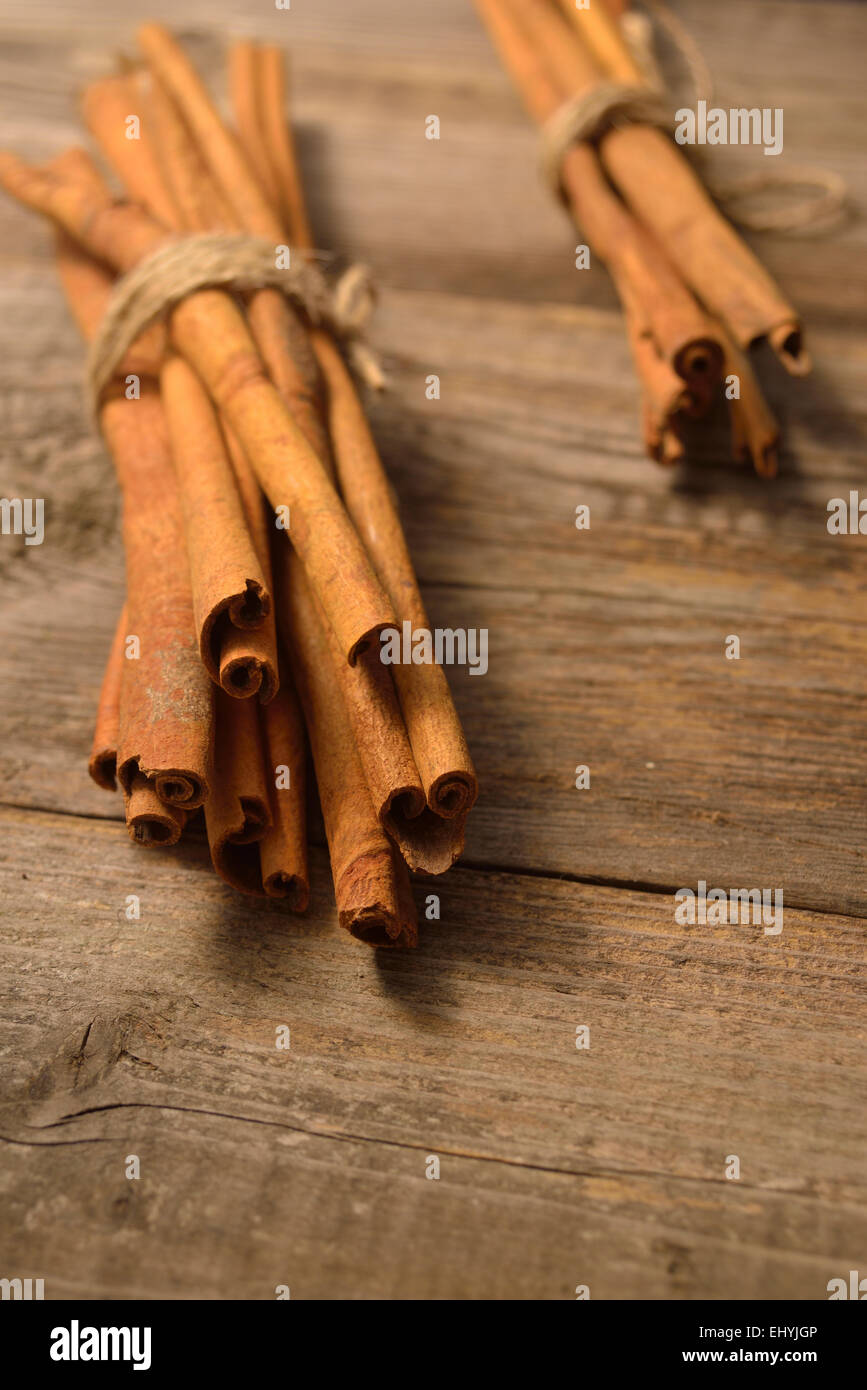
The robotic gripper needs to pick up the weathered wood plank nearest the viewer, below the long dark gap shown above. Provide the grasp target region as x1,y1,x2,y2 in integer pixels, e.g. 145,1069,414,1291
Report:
0,812,867,1298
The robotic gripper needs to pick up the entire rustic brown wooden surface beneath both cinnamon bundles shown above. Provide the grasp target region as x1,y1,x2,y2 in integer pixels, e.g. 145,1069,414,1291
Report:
0,0,867,1300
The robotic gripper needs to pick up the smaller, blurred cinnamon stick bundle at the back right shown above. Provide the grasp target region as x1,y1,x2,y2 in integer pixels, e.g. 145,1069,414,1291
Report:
477,0,810,477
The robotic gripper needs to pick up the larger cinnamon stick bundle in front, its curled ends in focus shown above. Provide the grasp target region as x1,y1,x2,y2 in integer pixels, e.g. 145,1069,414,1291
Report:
0,25,477,945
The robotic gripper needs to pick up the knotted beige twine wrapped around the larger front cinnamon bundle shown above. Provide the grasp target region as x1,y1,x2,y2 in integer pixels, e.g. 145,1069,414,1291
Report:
88,232,385,414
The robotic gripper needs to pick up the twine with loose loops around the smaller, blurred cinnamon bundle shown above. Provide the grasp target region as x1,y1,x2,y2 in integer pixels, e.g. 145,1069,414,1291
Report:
542,0,849,232
